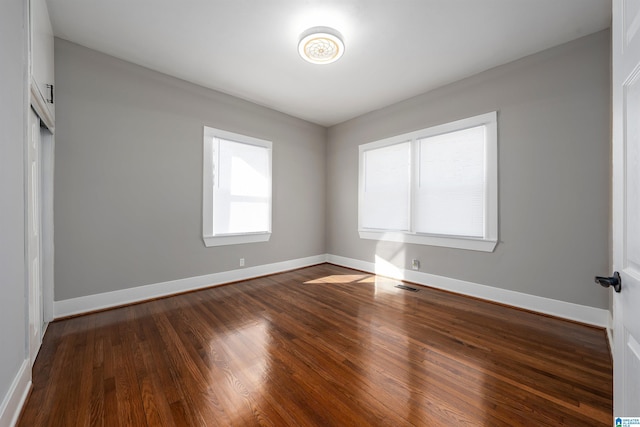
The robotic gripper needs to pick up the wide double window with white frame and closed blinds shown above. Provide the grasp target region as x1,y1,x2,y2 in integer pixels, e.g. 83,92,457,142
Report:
358,112,498,252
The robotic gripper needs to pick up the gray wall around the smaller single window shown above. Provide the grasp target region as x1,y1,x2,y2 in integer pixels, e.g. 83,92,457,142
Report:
54,39,326,301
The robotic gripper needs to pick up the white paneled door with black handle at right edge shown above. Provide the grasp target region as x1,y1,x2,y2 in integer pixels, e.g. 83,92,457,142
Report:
603,0,640,417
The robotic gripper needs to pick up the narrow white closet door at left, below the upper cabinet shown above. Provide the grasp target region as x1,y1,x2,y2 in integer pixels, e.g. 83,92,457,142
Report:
27,110,43,366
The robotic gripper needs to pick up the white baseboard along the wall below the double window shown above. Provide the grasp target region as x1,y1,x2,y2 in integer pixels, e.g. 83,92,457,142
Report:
327,255,609,328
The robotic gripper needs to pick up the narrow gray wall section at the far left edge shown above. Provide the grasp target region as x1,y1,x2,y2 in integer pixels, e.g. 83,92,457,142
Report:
0,0,28,415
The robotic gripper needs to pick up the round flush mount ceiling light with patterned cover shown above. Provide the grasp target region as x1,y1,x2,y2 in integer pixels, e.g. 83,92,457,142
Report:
298,27,344,64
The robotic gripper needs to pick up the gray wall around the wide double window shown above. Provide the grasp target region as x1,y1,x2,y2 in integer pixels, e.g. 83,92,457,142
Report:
327,31,610,309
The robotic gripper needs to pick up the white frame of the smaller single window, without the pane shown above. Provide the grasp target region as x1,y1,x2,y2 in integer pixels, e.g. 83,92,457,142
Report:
202,126,273,247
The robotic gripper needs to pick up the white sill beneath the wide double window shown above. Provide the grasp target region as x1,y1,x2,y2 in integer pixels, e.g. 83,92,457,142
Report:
359,230,498,252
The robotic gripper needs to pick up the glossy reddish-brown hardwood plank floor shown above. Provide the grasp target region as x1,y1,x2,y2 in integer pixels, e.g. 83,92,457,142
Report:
18,264,612,427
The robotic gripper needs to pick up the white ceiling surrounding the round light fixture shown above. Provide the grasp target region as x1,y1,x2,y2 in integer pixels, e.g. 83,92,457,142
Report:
48,0,611,126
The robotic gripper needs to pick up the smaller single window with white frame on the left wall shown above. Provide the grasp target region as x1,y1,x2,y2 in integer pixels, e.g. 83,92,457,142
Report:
202,126,271,246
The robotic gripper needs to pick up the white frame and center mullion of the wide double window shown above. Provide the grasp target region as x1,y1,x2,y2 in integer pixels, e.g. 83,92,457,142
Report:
358,111,498,252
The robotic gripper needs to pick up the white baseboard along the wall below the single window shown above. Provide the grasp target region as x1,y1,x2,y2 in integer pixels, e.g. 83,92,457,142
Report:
53,254,327,319
